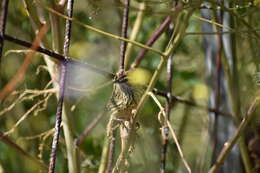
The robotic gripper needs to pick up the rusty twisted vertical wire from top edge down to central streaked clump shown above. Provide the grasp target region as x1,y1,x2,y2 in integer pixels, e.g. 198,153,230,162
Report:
119,0,130,72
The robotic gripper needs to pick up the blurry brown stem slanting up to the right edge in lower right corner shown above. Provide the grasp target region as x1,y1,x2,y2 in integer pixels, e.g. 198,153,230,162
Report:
208,97,260,173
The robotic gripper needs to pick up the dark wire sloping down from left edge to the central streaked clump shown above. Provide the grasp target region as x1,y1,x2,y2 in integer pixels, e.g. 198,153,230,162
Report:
4,35,115,79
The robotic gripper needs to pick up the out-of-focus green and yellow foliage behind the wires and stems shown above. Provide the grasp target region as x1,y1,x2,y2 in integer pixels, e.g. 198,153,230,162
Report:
0,0,260,173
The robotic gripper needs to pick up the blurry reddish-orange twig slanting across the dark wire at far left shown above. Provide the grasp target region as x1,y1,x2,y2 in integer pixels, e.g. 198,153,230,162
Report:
0,24,48,100
